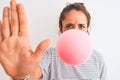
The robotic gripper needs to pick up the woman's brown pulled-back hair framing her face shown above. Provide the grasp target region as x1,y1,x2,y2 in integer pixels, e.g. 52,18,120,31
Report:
59,3,91,33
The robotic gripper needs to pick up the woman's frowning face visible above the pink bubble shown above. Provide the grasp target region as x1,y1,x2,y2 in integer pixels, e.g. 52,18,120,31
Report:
62,10,88,32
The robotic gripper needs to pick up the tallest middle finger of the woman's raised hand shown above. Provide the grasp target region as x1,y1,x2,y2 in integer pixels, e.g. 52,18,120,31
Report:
10,0,19,36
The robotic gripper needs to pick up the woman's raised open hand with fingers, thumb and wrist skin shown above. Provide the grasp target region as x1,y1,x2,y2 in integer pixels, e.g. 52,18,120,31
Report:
0,0,50,80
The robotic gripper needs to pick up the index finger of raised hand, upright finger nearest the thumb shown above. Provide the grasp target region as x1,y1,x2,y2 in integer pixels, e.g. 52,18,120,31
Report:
17,4,28,37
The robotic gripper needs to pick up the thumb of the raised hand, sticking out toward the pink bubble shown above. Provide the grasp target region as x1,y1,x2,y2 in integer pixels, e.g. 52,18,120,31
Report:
34,39,51,60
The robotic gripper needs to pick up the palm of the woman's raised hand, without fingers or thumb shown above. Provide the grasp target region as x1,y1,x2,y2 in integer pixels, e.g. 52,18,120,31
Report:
0,36,36,76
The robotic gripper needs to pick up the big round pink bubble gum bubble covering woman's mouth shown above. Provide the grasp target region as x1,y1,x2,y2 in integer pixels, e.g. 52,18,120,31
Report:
56,29,92,65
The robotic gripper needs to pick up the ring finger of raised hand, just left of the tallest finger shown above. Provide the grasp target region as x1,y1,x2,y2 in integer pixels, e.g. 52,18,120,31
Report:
1,7,10,39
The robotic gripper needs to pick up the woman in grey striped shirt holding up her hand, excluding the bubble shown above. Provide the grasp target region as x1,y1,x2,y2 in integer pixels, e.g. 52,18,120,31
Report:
0,0,106,80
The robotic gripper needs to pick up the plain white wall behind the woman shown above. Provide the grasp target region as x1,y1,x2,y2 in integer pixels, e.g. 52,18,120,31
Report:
0,0,120,80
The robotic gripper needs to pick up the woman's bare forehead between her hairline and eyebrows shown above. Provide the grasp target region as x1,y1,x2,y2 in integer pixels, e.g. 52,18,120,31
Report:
63,10,87,23
